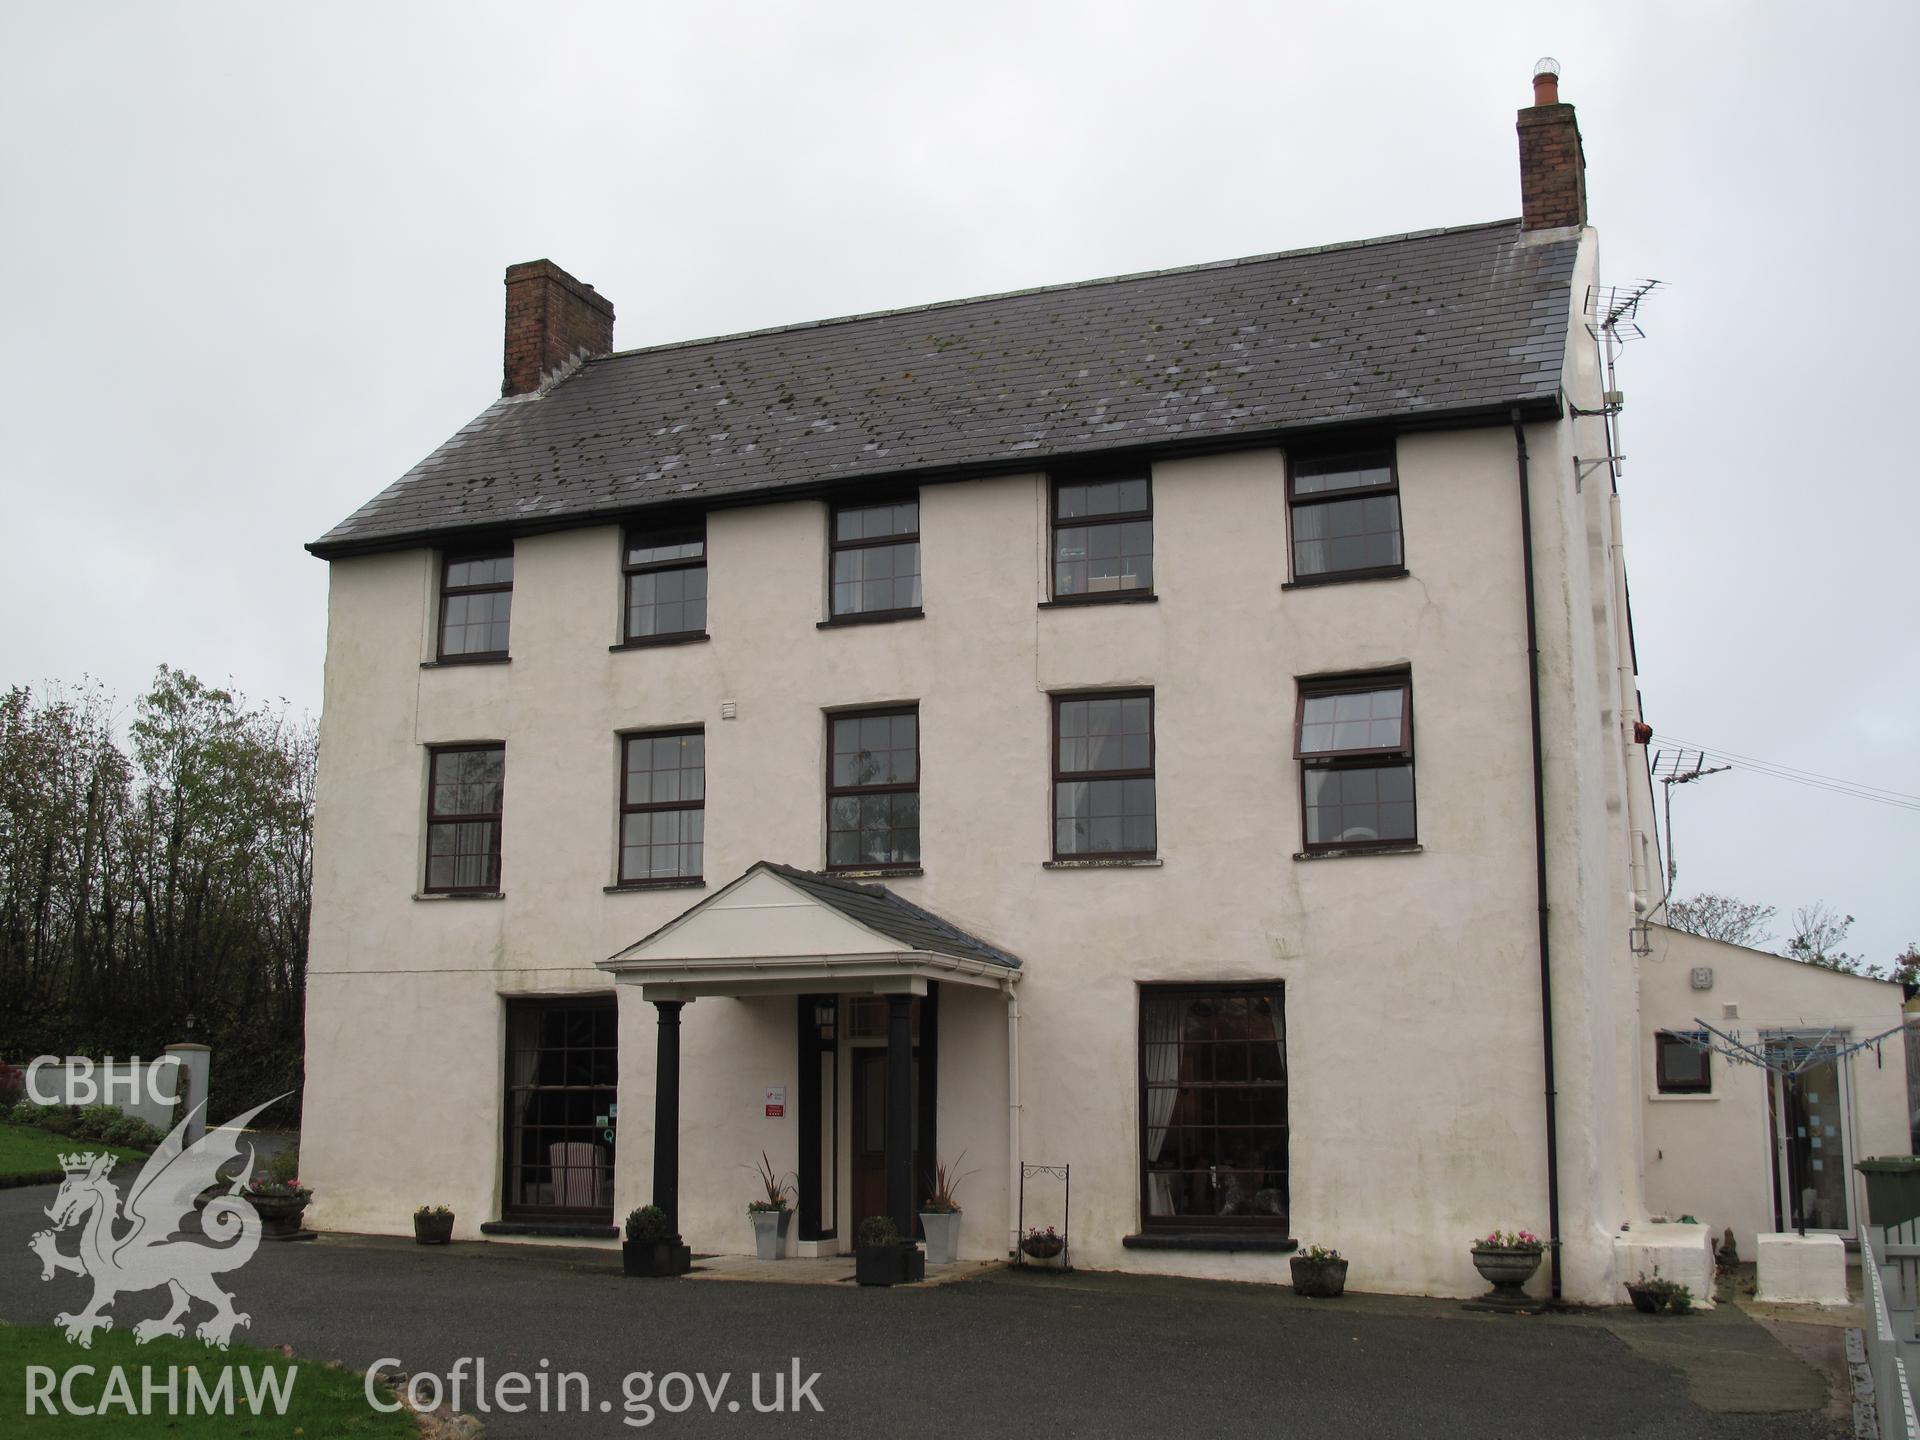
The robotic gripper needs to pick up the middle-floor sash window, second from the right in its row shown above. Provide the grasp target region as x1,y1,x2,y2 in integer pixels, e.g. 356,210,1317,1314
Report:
1054,691,1158,860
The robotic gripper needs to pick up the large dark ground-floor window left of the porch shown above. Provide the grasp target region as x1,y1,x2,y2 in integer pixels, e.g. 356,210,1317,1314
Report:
501,995,620,1219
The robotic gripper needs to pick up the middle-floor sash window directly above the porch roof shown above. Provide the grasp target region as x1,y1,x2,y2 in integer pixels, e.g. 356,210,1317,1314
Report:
828,708,920,870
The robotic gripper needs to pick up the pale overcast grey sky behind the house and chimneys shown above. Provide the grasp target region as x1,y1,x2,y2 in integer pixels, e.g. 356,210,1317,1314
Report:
0,0,1920,960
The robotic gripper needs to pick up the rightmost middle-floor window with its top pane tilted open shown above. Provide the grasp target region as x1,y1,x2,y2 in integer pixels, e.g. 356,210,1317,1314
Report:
1294,676,1415,851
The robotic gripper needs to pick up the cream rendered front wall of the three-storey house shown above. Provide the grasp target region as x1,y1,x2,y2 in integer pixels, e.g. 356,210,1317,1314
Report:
303,228,1697,1300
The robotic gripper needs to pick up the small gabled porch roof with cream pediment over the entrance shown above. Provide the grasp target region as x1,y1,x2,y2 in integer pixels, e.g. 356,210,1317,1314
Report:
599,860,1021,1000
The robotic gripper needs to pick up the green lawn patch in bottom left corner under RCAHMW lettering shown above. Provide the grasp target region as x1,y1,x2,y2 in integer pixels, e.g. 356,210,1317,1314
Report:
0,1321,415,1440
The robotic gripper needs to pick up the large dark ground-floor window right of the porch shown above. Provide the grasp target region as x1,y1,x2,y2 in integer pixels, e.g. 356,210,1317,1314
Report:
1140,981,1288,1231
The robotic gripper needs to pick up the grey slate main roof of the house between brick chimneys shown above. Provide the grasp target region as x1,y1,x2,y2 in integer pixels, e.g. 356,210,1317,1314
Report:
307,221,1578,557
